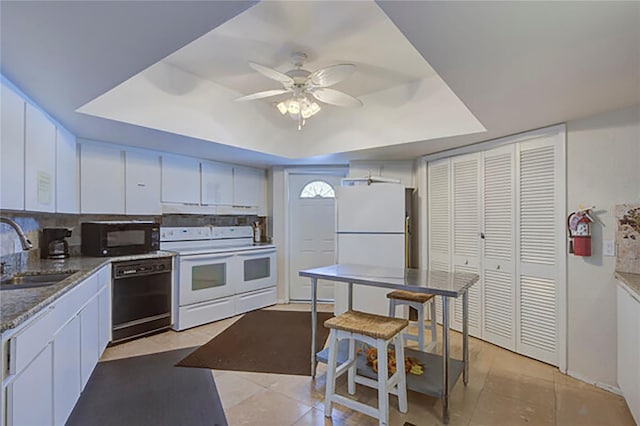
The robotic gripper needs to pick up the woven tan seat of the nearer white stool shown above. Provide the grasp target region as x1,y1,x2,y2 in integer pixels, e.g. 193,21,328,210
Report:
324,311,409,340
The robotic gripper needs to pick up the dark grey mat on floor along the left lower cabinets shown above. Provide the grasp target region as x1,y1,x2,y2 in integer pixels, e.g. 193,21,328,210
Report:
67,348,227,426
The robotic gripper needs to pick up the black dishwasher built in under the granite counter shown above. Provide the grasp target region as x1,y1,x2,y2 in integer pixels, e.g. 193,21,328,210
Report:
111,257,172,343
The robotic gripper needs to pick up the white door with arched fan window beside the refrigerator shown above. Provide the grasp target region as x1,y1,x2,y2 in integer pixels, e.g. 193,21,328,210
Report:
289,174,343,301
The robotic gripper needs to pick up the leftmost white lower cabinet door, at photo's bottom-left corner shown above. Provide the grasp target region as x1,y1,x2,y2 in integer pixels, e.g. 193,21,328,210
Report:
7,344,53,426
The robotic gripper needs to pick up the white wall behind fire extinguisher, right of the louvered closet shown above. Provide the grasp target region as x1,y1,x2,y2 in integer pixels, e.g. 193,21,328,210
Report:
567,106,640,388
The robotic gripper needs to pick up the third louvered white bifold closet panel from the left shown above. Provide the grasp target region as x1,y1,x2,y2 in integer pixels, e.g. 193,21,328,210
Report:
482,145,516,350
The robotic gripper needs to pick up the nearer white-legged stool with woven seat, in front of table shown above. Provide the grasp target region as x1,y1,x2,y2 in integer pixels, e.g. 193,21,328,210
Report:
324,311,409,425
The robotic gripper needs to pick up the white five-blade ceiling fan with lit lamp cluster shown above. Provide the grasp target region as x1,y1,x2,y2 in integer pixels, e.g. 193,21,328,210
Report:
236,52,362,130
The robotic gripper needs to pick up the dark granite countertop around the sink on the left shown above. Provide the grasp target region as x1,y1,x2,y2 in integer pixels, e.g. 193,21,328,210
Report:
0,251,175,333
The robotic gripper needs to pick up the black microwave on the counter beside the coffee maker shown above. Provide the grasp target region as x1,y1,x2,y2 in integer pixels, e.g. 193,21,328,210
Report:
80,221,160,256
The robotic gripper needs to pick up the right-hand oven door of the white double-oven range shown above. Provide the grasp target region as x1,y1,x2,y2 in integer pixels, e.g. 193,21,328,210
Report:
236,248,278,293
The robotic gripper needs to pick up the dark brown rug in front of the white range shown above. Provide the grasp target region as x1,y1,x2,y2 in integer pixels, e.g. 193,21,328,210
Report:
177,310,333,376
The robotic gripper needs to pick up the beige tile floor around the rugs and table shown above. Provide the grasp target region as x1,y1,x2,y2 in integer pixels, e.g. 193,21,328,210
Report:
102,305,635,426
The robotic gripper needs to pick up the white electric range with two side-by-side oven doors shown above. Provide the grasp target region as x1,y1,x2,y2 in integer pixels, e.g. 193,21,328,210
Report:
160,226,277,330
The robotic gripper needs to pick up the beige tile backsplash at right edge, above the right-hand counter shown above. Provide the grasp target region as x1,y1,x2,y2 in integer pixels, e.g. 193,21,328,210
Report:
615,204,640,274
